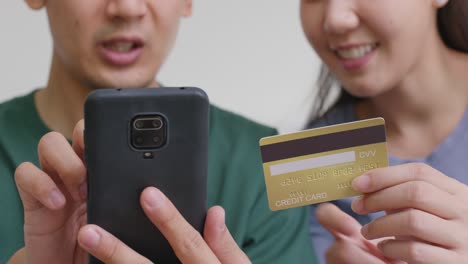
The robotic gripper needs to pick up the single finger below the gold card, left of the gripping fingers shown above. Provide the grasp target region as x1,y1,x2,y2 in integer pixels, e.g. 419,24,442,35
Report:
316,203,362,239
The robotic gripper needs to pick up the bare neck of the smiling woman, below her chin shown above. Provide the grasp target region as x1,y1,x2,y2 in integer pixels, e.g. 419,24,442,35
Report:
357,40,468,158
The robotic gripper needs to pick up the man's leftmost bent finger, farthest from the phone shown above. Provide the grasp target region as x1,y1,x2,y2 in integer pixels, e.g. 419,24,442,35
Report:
15,162,66,211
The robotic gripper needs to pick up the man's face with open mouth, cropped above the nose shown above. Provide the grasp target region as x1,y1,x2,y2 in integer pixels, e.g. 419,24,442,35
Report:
31,0,191,89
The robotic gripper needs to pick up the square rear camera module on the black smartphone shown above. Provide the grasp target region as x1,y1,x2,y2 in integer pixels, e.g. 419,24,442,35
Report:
130,115,167,150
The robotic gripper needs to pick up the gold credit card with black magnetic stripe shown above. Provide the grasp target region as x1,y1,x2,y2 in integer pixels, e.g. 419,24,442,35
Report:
260,118,388,211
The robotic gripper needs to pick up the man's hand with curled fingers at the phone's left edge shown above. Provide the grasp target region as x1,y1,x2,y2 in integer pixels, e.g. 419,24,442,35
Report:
15,121,87,264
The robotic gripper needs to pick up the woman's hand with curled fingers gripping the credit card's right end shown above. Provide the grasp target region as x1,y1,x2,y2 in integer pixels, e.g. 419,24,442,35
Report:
352,163,468,264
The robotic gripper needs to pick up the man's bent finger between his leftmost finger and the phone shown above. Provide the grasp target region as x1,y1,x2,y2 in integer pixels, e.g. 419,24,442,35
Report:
38,132,86,201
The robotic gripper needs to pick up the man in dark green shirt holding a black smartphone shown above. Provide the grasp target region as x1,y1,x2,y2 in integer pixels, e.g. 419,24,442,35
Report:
0,0,313,263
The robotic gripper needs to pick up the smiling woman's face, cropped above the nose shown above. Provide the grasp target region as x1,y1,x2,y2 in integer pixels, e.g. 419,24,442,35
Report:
301,0,438,97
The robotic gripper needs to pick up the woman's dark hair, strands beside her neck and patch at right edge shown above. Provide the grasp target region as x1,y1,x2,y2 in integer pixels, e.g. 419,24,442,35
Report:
309,0,468,121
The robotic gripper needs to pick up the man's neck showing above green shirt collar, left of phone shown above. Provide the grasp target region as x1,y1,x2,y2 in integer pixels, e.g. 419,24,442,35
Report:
34,56,158,139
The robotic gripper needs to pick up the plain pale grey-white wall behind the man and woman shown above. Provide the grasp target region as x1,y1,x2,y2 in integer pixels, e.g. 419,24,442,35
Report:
0,0,319,131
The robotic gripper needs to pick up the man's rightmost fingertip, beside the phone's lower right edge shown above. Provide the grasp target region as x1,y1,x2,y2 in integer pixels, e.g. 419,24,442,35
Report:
204,206,251,264
